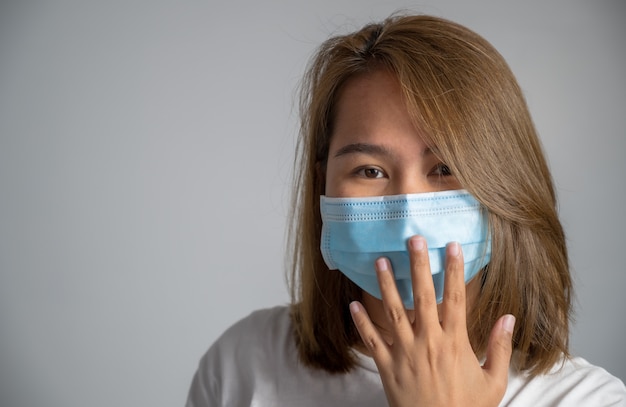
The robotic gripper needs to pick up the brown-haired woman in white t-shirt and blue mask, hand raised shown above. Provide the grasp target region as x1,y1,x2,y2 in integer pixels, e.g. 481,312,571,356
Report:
188,16,626,406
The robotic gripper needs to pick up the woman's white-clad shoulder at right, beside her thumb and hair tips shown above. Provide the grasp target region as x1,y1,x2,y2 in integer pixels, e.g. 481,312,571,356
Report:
502,357,626,406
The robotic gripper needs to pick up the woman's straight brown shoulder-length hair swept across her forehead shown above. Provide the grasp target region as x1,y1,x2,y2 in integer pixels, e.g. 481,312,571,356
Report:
288,16,571,374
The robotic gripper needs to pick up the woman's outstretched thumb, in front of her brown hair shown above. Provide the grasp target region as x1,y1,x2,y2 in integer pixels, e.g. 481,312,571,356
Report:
483,314,515,383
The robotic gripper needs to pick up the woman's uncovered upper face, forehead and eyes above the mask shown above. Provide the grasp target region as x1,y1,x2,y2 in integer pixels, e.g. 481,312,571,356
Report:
325,70,461,197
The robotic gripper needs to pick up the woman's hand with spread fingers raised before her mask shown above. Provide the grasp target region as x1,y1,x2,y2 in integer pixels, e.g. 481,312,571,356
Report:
350,236,515,407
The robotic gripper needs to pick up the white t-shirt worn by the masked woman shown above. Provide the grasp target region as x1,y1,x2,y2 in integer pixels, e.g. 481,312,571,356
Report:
187,307,626,407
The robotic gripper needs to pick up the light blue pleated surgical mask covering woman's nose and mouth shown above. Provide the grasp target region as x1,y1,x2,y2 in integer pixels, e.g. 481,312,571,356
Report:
320,190,491,309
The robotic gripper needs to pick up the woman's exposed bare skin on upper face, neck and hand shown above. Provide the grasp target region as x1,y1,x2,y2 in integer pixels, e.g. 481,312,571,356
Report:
325,70,515,406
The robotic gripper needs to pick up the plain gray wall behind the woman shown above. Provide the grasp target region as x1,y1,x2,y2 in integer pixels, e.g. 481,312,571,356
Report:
0,0,626,407
